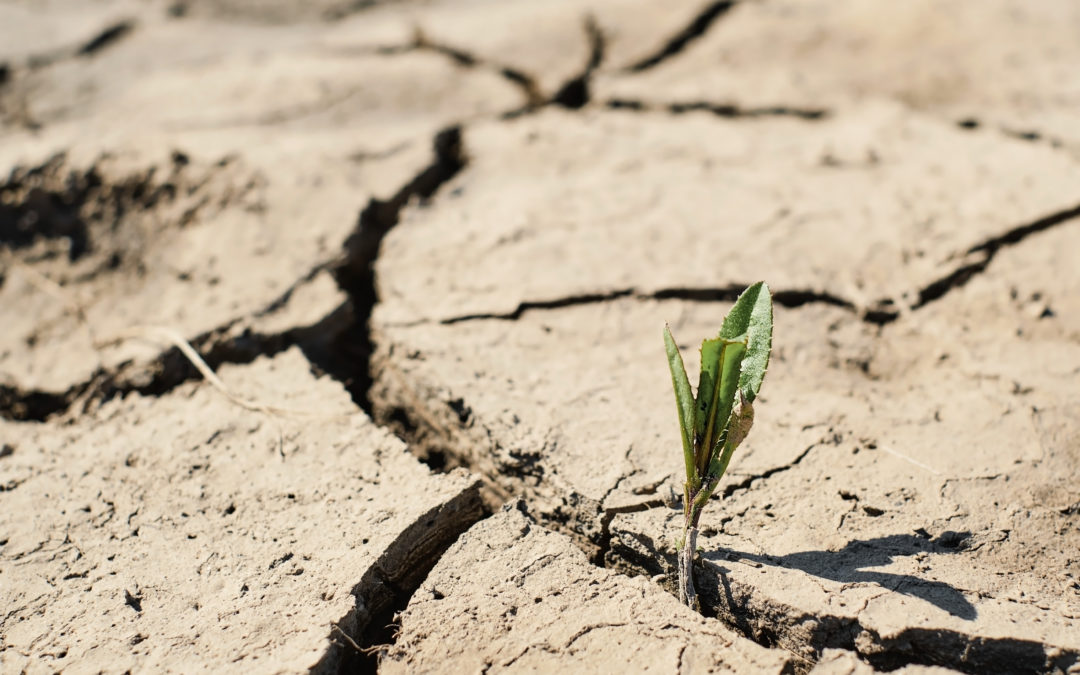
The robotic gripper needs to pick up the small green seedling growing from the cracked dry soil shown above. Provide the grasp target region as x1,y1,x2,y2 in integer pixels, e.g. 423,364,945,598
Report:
664,281,772,609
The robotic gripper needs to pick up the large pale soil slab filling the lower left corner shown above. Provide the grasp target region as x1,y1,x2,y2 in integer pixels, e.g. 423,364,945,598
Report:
0,348,481,673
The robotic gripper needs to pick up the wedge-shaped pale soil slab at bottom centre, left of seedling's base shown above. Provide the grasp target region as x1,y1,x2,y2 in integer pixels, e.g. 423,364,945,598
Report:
384,502,791,673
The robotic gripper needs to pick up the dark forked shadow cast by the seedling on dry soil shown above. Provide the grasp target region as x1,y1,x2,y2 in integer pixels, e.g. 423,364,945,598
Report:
702,529,977,621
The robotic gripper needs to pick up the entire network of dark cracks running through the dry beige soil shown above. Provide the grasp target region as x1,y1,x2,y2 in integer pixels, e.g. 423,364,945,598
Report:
0,0,1080,672
